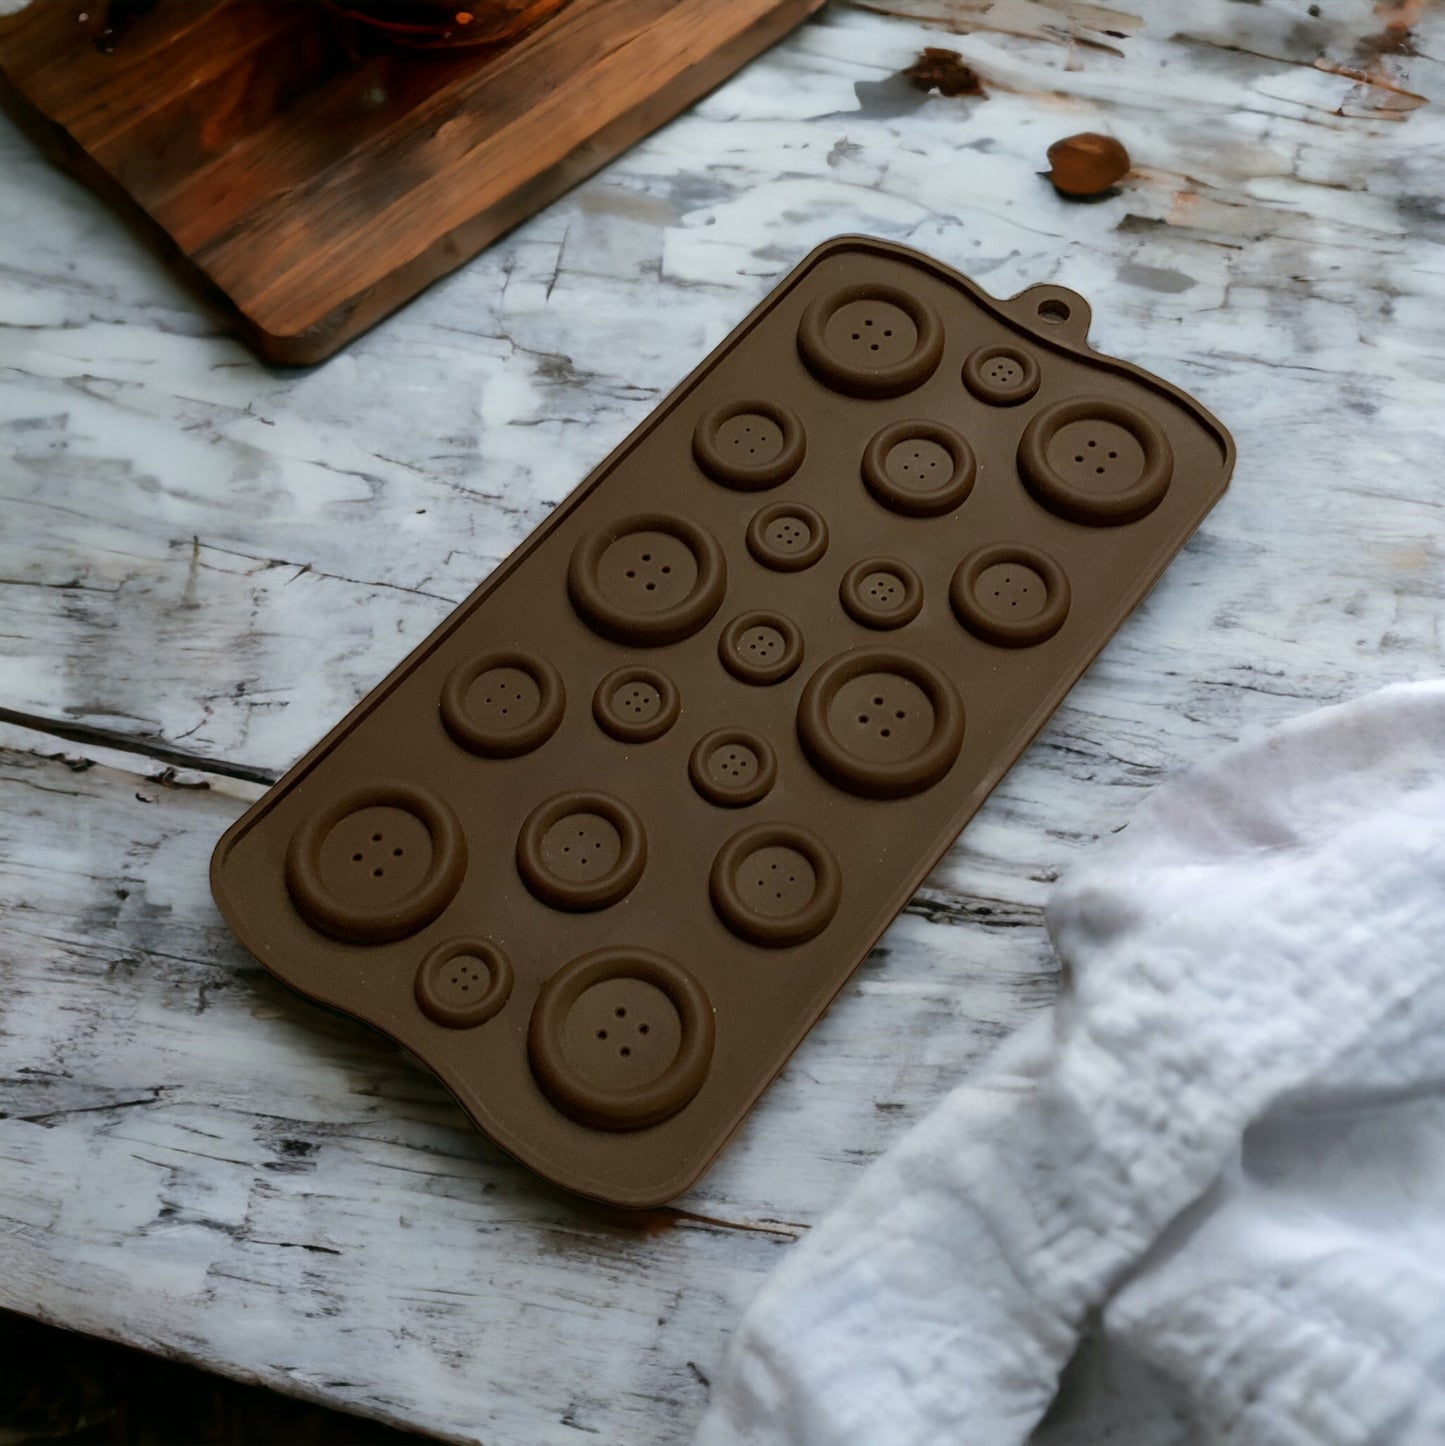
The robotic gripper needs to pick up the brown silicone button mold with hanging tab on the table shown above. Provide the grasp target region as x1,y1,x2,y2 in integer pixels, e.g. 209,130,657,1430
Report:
213,237,1234,1206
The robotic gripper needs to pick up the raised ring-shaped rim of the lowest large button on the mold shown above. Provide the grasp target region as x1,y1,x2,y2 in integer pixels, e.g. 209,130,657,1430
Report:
527,944,716,1129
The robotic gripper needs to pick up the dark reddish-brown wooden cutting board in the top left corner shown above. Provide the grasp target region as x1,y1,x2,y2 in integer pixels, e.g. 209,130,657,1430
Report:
0,0,822,363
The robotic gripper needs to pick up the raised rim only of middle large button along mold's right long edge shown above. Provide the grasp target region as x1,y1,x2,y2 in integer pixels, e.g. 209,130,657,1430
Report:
797,648,963,798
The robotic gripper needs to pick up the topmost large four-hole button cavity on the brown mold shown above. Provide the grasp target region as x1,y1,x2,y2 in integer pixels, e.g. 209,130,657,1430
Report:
798,282,943,396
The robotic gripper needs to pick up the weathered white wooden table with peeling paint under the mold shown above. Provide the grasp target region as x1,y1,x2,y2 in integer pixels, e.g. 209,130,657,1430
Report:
0,0,1445,1446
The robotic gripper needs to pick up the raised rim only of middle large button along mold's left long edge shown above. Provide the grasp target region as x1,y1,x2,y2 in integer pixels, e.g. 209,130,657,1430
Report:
567,512,728,648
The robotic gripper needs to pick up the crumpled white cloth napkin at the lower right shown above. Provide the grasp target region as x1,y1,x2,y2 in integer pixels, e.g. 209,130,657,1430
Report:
697,683,1445,1446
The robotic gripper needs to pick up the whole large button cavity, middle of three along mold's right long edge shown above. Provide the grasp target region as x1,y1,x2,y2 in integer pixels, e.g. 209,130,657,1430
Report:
797,648,963,798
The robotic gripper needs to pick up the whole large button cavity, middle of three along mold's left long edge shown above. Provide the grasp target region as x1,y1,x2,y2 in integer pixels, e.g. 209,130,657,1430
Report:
567,512,728,648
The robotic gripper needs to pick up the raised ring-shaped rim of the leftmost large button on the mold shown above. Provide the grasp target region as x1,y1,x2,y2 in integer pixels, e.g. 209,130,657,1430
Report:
285,784,467,944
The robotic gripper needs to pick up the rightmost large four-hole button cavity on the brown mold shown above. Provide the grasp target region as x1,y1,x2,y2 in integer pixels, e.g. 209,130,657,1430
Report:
1018,396,1175,528
